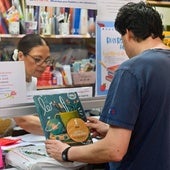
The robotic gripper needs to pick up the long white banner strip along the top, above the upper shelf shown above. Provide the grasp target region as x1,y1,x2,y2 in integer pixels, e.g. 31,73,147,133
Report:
26,0,97,9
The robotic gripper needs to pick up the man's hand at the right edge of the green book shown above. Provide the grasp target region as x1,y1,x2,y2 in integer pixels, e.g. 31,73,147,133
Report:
86,116,109,138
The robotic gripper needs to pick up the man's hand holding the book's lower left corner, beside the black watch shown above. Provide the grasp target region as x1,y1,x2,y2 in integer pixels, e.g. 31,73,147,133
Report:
45,139,69,161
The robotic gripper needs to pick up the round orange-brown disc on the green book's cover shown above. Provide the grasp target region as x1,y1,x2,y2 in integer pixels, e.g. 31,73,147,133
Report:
67,118,90,142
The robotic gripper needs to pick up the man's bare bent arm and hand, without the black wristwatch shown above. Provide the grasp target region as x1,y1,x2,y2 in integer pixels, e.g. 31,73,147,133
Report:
46,126,131,163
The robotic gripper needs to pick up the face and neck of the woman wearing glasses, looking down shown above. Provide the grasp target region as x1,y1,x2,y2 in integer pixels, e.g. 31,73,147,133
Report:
19,45,50,82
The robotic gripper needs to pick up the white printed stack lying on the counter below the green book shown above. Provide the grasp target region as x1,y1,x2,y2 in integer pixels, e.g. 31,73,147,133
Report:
5,145,86,170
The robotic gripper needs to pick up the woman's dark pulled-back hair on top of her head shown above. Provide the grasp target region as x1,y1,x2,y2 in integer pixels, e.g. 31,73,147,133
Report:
17,34,49,55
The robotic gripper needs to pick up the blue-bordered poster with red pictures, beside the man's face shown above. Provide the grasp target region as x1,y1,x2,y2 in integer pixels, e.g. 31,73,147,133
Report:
96,21,128,96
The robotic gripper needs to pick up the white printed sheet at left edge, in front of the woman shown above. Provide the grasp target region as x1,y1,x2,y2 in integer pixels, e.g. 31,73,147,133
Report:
0,61,26,106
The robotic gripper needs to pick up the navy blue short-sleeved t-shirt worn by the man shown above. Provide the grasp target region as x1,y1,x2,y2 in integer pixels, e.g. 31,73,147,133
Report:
100,49,170,170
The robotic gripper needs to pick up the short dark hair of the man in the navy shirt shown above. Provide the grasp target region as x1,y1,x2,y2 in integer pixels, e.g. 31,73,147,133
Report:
115,1,163,41
